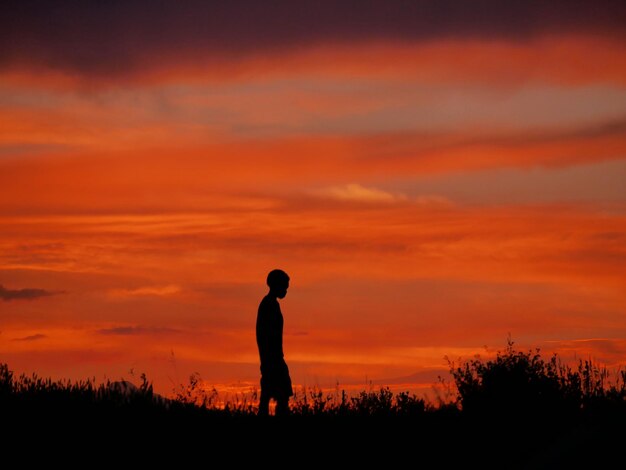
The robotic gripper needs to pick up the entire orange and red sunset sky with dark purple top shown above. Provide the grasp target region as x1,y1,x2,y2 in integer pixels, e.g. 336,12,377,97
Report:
0,0,626,394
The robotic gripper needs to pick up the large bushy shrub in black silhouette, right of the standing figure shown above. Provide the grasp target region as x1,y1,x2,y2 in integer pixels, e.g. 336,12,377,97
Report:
449,339,626,419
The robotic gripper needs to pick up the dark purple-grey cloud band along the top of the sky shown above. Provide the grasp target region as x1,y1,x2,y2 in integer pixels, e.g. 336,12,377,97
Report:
0,0,626,78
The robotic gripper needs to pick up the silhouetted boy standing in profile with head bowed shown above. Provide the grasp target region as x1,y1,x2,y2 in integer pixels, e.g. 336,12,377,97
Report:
256,269,293,416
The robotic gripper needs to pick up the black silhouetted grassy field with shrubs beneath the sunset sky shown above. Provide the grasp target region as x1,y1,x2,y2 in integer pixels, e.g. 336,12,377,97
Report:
0,344,626,469
